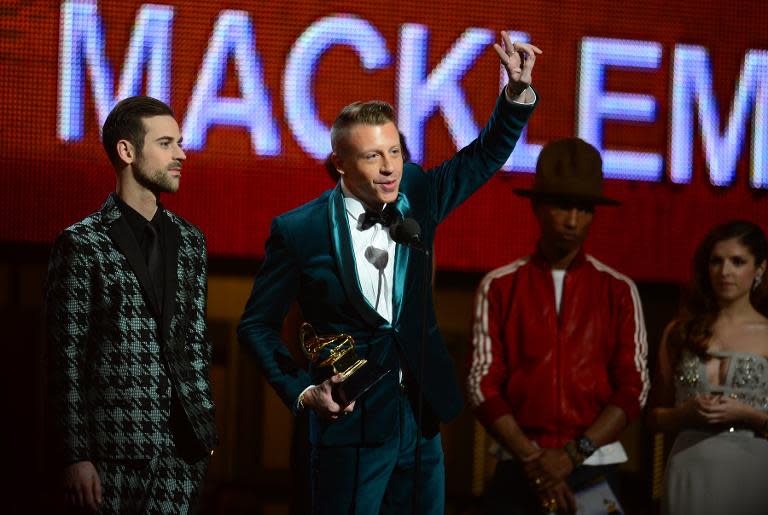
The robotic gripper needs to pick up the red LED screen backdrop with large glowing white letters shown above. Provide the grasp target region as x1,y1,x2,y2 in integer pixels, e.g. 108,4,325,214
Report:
0,0,768,281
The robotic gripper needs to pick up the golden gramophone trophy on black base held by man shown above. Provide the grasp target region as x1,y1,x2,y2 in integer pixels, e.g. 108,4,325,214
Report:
299,323,389,406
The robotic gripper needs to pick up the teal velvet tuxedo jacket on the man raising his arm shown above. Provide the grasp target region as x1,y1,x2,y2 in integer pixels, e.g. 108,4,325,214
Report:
238,90,535,446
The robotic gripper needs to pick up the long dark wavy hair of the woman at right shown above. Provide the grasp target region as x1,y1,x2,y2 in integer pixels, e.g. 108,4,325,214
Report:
670,220,768,356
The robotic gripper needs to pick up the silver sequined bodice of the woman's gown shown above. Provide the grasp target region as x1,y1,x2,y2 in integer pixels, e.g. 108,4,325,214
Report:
675,350,768,411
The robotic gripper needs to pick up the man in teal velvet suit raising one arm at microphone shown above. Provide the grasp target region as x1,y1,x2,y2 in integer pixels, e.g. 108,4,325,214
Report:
238,33,541,515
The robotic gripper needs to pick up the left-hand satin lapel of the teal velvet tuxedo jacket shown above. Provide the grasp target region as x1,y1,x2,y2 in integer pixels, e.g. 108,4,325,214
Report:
328,183,387,327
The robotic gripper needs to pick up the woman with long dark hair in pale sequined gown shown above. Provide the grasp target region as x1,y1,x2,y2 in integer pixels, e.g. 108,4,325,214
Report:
649,221,768,515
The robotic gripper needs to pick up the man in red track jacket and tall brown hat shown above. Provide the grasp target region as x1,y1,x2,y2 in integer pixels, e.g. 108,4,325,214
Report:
467,138,648,514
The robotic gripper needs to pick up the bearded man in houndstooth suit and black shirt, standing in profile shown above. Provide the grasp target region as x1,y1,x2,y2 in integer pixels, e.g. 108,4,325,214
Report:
45,97,217,514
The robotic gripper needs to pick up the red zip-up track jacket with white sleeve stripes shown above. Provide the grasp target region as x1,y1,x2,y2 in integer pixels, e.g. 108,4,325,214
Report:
467,250,649,448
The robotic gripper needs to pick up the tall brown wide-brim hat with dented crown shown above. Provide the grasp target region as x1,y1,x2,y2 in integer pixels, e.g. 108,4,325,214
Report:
514,138,621,206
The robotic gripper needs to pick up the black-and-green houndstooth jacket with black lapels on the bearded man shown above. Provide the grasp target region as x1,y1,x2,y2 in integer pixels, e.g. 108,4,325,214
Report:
45,194,217,462
